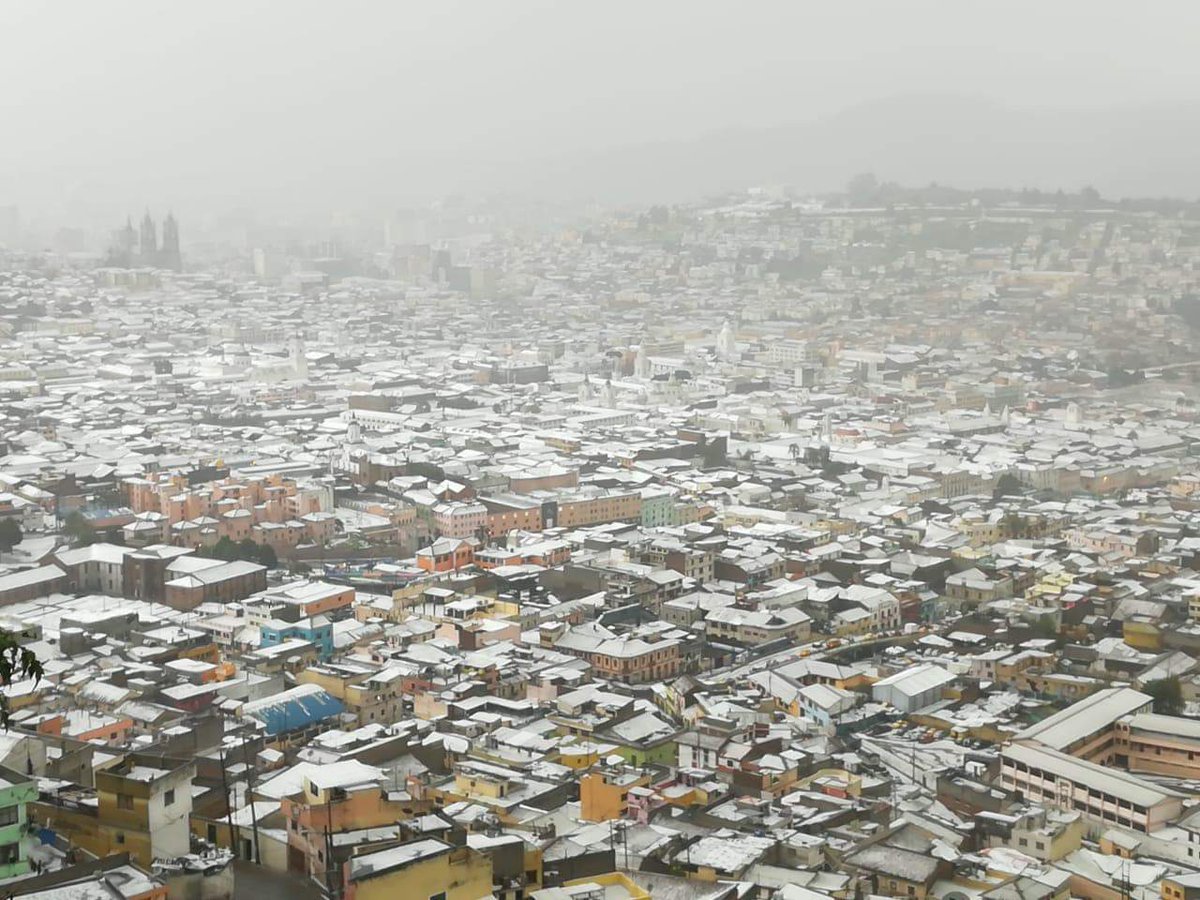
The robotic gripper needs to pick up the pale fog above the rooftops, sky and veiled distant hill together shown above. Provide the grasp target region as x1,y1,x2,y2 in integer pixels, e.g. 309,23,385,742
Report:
7,0,1200,222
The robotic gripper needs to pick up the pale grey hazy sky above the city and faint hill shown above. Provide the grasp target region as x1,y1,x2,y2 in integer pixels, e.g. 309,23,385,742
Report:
0,0,1200,224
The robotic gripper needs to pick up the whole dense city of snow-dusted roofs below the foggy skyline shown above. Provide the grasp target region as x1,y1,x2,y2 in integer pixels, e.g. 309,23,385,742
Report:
0,183,1200,900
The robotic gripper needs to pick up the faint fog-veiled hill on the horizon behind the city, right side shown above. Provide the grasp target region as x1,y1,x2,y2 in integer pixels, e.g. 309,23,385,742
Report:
480,95,1200,203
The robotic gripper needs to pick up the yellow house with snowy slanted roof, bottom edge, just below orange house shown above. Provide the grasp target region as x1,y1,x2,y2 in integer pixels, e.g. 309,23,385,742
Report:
343,838,492,900
